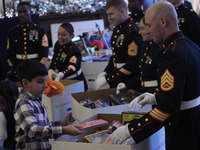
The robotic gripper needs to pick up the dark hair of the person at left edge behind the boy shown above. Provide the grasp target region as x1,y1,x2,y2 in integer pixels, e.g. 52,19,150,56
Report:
0,80,19,110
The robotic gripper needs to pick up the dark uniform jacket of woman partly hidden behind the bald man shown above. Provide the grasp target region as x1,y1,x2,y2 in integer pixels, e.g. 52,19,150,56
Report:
124,41,162,93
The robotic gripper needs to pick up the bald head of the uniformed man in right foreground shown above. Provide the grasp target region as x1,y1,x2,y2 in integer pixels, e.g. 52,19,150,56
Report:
145,1,178,42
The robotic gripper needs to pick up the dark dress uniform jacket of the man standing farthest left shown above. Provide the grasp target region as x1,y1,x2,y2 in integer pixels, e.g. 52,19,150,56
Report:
7,23,49,81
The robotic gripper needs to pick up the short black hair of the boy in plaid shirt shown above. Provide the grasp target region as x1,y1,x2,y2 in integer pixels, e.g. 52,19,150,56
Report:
17,59,48,83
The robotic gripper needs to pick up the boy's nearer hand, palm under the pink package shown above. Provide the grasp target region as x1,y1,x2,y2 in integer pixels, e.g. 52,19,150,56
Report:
62,125,84,136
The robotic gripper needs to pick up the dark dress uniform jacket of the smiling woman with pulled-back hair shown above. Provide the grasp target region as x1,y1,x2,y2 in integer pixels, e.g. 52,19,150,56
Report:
49,41,88,90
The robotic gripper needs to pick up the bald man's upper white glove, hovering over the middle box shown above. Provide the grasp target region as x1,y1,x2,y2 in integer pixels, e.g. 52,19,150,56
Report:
129,92,157,110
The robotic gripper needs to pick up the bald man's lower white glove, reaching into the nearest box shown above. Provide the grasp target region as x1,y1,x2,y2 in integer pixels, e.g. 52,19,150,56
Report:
111,124,131,144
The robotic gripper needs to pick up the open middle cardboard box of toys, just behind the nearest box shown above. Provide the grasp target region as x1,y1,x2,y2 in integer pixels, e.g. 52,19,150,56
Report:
71,88,152,122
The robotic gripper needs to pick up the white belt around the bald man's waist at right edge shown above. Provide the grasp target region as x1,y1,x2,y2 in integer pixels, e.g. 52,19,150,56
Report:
180,96,200,110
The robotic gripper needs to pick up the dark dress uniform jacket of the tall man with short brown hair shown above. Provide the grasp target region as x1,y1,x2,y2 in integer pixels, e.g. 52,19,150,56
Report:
104,18,144,87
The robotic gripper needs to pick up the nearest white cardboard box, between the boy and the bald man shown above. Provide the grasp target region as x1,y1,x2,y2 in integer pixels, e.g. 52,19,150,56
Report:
52,114,165,150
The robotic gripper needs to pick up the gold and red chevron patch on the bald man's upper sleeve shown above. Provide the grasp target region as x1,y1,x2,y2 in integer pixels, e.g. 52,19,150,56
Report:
160,69,174,91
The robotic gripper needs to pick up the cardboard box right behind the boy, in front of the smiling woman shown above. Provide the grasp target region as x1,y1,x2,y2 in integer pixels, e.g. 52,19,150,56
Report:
42,79,84,121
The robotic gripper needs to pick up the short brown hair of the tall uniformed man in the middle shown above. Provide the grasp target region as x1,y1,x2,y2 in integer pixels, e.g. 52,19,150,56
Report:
106,0,128,10
